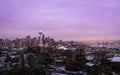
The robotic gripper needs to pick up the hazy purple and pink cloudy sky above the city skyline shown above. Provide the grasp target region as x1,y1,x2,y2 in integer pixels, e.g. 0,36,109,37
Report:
0,0,120,40
